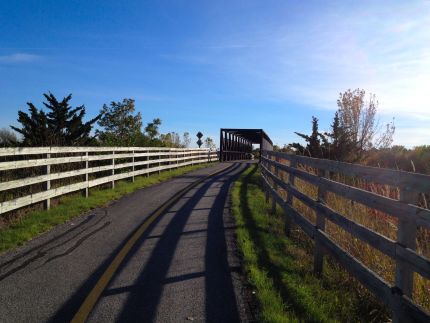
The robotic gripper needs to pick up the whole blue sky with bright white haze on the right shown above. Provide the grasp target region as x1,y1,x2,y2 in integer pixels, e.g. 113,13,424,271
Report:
0,0,430,146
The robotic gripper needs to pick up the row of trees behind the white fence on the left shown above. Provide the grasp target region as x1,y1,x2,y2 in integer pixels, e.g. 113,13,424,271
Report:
0,93,214,148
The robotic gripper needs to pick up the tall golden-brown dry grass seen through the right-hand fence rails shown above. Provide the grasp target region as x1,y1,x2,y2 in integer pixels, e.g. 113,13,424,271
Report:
272,160,430,310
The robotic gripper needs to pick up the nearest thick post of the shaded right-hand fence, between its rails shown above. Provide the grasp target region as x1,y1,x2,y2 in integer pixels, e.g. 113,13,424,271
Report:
393,187,418,323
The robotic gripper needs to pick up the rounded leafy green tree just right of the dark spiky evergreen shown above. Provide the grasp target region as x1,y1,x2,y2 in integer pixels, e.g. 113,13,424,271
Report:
96,99,142,146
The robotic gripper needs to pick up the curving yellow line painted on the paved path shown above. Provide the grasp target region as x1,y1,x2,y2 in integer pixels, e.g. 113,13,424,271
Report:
71,165,232,323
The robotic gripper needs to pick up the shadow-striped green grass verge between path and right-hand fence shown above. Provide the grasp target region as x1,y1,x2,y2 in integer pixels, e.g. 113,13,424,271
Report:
232,165,386,322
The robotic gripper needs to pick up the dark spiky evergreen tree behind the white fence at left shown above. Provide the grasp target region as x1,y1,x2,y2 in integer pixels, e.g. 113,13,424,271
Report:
11,93,100,146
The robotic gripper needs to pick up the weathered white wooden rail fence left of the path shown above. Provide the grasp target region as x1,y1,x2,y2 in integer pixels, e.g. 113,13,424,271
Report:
0,147,217,214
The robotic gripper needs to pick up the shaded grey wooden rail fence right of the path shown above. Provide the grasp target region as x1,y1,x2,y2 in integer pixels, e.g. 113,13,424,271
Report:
261,151,430,322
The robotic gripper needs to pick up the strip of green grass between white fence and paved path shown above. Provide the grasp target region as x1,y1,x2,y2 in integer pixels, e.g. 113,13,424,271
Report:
0,163,215,253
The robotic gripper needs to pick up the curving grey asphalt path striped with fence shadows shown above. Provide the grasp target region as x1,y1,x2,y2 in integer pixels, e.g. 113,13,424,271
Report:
0,163,251,322
